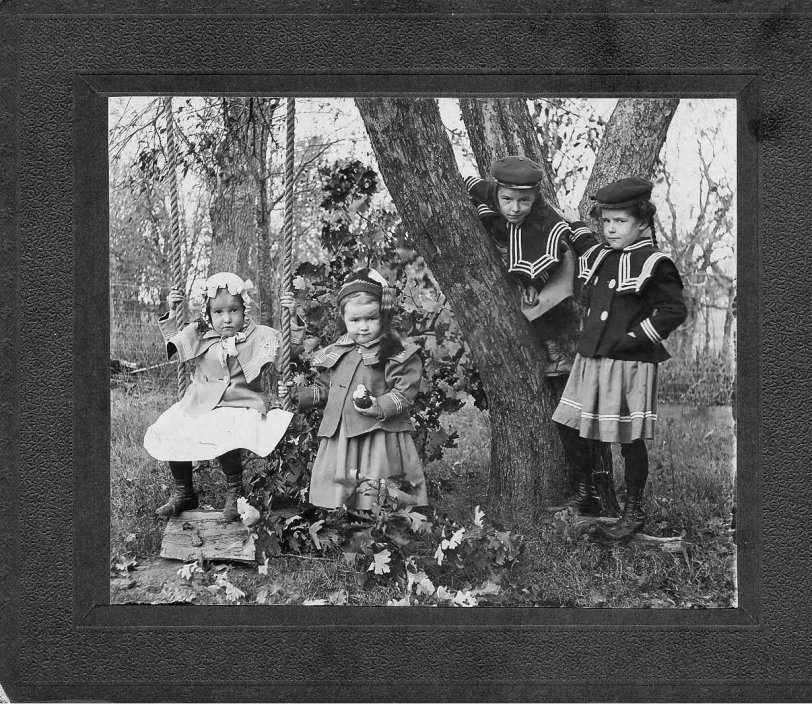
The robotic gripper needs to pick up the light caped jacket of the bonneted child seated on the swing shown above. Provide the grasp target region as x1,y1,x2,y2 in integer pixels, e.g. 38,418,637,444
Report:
158,311,305,417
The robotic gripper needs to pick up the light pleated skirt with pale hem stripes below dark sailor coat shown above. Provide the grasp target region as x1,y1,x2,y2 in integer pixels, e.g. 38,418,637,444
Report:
553,354,657,443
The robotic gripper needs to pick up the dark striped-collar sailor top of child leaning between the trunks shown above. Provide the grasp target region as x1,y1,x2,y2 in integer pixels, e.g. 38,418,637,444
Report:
465,176,595,288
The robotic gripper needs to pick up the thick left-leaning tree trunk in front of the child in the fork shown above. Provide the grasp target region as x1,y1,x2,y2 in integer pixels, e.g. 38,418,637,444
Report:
356,98,561,524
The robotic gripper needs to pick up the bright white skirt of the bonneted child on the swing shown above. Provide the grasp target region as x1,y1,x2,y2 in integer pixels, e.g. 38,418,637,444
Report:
144,403,293,462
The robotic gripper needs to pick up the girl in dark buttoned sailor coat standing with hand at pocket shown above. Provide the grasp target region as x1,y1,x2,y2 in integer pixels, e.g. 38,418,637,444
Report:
553,178,687,539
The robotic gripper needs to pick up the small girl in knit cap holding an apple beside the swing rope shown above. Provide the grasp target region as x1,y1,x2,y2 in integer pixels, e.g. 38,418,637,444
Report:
279,269,428,511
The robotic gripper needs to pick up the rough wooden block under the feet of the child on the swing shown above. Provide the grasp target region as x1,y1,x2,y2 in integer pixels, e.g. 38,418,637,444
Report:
161,511,256,562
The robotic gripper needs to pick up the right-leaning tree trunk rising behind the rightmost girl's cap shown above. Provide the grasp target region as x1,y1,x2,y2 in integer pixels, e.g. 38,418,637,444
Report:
579,98,679,219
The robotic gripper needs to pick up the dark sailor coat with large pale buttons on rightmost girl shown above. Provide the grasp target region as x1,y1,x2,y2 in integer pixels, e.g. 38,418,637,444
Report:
575,228,688,362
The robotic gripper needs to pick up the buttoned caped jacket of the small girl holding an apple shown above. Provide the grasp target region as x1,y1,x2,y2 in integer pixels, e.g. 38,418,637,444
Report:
298,335,423,438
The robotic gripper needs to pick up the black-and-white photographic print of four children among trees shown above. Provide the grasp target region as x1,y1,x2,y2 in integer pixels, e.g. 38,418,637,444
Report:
108,96,737,609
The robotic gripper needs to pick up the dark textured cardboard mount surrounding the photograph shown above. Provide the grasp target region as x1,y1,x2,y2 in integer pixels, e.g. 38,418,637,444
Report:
0,2,812,701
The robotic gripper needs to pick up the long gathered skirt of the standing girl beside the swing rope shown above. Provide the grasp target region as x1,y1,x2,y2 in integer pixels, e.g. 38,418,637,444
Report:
309,423,428,510
